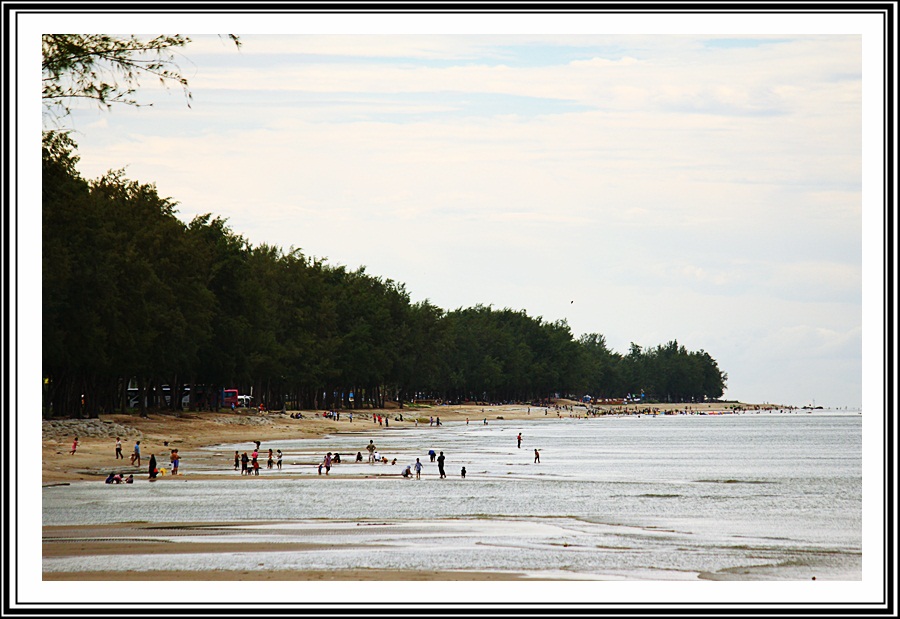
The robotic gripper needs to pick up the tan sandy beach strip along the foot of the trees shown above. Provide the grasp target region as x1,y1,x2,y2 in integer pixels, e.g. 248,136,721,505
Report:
42,400,764,486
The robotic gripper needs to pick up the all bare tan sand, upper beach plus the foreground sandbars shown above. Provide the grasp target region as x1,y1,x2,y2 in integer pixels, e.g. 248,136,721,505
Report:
42,401,768,581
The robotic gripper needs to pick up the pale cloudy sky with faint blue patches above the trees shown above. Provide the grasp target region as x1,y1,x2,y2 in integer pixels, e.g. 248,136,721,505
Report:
28,16,882,407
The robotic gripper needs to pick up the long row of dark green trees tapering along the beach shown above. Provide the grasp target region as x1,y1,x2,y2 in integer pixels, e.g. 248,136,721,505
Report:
42,131,727,417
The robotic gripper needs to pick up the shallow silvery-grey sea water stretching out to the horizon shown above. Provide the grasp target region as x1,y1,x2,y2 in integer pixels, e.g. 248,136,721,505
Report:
42,409,863,581
